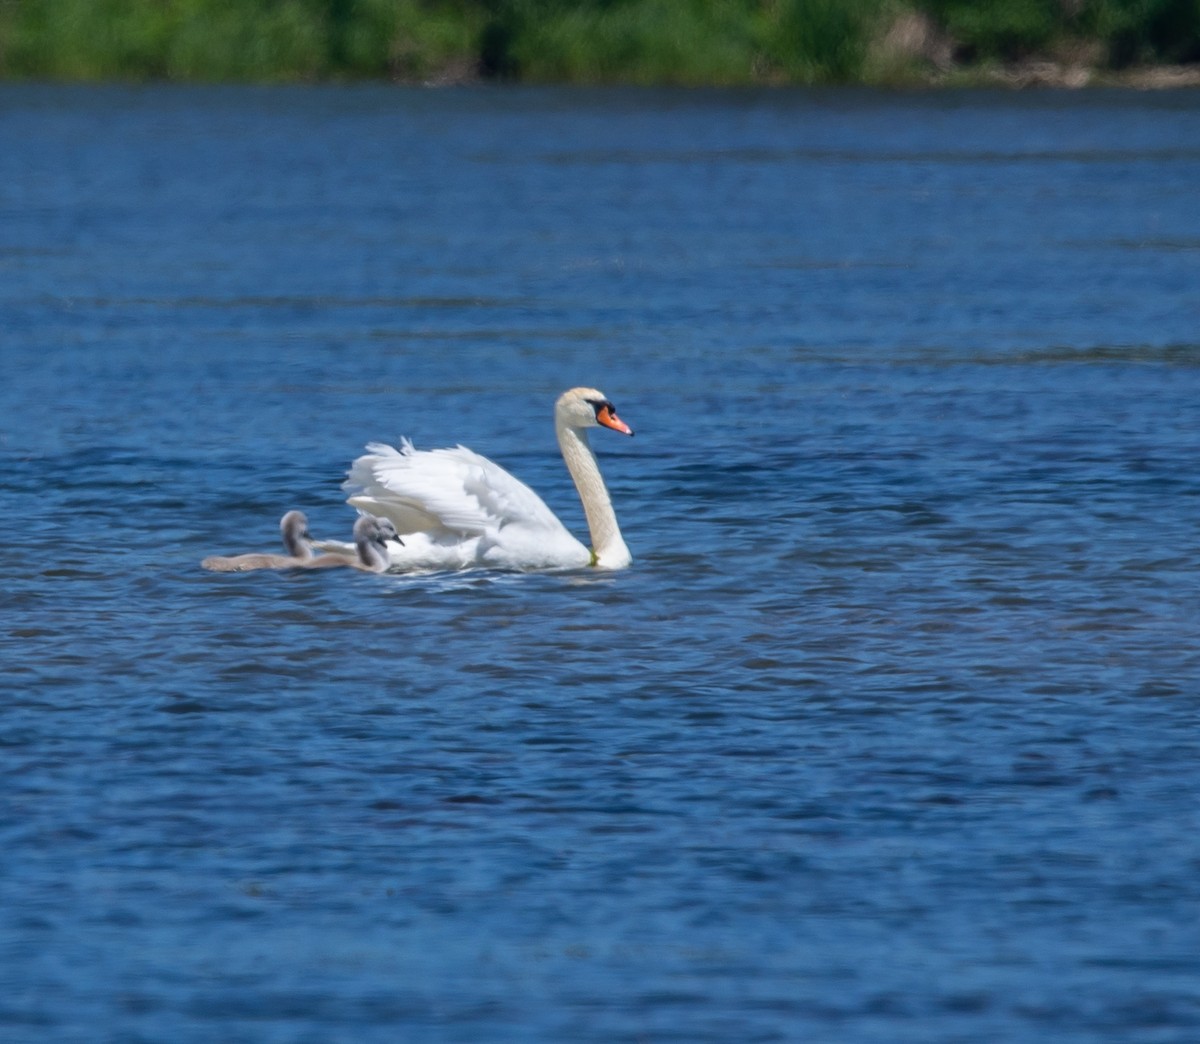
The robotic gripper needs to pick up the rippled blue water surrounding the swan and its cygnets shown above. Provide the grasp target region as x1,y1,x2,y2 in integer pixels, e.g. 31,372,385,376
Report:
0,86,1200,1044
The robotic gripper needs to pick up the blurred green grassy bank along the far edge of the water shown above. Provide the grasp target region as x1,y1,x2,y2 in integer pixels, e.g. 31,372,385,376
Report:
0,0,1200,84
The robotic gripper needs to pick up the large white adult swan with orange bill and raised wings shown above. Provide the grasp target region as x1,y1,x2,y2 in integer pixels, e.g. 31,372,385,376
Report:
340,388,634,570
